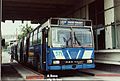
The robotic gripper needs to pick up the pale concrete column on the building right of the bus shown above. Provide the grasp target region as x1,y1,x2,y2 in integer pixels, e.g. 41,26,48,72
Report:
104,0,114,49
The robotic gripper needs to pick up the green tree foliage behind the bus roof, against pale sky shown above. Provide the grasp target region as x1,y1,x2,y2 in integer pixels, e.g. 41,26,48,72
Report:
18,23,33,40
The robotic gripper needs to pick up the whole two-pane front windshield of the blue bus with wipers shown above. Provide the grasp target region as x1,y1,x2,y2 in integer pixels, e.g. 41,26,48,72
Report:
52,27,93,47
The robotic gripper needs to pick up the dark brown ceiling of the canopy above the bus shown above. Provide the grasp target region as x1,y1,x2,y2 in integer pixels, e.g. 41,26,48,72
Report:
2,0,82,23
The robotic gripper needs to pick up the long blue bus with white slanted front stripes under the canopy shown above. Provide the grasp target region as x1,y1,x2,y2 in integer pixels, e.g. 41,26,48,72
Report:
17,18,95,71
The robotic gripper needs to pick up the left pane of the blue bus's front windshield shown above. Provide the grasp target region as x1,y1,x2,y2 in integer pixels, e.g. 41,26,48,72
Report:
52,28,71,47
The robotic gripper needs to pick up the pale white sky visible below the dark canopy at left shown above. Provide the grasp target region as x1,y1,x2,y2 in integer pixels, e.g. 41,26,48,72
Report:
1,20,39,35
